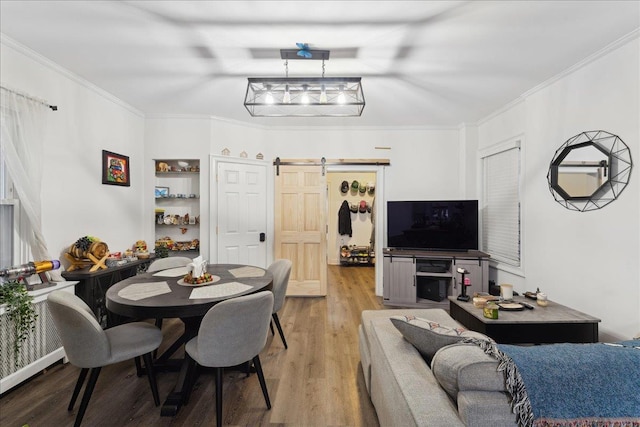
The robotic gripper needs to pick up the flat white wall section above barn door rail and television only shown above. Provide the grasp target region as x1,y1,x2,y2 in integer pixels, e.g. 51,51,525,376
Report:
269,128,463,200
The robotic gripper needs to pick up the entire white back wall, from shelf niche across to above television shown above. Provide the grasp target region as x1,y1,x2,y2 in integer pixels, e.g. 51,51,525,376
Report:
145,117,464,259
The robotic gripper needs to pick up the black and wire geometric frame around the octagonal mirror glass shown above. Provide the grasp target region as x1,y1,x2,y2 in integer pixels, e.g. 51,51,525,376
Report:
547,130,633,212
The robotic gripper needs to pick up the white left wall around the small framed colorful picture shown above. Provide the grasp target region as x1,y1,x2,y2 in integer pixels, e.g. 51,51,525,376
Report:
0,36,147,263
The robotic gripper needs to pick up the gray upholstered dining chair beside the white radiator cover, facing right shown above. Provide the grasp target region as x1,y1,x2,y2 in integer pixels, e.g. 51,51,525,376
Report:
47,290,162,427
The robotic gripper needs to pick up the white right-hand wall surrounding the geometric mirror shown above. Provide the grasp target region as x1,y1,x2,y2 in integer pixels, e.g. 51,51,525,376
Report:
478,35,640,340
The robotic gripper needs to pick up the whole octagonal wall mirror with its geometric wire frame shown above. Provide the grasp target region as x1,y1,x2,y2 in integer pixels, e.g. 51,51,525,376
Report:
547,131,632,211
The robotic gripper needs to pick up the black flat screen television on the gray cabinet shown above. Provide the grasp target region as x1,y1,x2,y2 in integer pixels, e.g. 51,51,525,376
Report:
387,200,478,251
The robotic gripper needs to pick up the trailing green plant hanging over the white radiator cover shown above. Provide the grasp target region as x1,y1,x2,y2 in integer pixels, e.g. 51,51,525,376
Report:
0,280,38,366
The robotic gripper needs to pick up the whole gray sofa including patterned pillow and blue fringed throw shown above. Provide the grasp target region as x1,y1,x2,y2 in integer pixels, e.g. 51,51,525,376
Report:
359,309,640,427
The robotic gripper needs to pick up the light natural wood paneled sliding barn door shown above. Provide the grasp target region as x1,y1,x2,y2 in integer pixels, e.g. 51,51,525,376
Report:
275,165,327,296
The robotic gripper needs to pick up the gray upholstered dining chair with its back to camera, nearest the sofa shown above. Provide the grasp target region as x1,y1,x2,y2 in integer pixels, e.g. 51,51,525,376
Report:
185,291,273,427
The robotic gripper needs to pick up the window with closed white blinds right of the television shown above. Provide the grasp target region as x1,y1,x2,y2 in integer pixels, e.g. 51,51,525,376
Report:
481,140,521,267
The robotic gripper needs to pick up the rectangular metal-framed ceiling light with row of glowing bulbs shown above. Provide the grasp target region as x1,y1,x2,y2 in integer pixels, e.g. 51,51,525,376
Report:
244,49,365,117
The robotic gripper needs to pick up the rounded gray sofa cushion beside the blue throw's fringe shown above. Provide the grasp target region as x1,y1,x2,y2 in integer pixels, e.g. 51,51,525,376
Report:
431,343,506,399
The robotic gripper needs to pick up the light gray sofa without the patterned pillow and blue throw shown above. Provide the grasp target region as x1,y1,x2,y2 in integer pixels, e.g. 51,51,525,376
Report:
358,309,517,427
